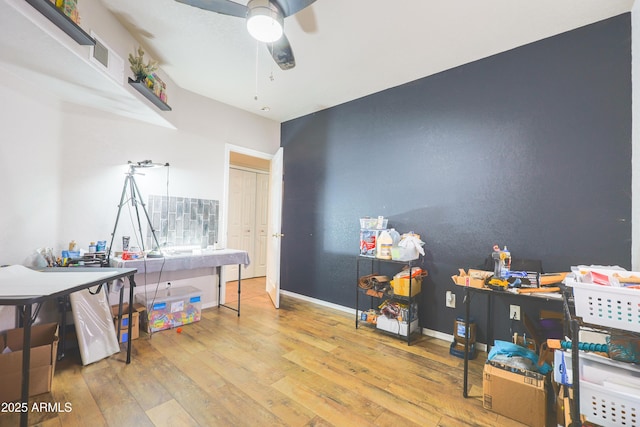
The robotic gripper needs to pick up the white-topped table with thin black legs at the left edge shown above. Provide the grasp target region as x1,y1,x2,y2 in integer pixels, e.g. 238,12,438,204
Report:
0,266,136,427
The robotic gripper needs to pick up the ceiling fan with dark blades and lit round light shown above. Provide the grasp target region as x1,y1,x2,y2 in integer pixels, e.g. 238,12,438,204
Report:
176,0,316,70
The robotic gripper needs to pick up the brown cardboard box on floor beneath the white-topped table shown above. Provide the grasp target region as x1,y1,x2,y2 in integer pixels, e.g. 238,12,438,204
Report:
0,323,58,402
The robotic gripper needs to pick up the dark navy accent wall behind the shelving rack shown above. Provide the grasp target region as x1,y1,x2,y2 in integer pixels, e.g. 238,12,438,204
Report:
281,14,631,341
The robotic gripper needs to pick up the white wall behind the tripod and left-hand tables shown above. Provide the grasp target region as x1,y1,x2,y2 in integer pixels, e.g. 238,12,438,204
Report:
0,2,280,330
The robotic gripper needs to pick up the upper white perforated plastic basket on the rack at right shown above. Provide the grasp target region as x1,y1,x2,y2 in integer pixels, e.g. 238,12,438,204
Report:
566,281,640,332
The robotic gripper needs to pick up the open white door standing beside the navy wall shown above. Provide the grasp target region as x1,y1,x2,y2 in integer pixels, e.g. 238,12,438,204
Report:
266,147,284,308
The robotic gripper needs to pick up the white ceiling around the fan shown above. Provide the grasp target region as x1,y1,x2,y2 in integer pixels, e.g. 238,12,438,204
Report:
7,0,633,122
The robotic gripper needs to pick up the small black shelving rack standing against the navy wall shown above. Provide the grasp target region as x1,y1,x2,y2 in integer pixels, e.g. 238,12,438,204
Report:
356,255,421,345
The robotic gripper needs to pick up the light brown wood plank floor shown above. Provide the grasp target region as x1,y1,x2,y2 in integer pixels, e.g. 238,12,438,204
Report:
0,278,521,427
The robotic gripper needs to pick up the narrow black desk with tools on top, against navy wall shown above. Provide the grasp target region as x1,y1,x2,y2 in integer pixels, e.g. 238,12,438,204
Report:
462,286,563,397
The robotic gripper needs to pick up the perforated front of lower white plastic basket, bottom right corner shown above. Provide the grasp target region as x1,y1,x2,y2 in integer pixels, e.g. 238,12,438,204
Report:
580,381,640,427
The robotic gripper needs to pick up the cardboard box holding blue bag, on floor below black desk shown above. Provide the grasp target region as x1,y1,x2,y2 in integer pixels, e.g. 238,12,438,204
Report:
482,362,547,427
